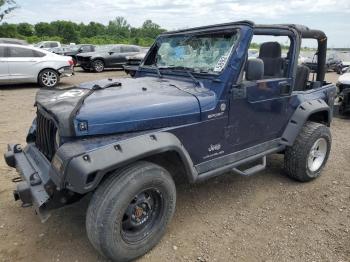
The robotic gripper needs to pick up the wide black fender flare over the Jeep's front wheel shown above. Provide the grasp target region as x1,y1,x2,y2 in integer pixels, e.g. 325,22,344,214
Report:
60,132,198,194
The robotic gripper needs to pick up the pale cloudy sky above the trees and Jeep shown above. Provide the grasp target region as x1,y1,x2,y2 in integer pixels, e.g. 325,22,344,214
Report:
2,0,350,48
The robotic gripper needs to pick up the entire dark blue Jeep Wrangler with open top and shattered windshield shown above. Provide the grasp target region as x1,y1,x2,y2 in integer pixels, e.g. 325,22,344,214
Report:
5,21,336,261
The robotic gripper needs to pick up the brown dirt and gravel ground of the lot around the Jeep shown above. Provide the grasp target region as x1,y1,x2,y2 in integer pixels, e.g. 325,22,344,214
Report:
0,69,350,261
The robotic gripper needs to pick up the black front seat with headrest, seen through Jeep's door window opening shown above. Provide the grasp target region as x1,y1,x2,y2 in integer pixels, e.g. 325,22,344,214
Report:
259,42,284,78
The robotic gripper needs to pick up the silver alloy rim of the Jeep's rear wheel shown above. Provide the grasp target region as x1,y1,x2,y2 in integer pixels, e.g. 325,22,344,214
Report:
307,137,328,172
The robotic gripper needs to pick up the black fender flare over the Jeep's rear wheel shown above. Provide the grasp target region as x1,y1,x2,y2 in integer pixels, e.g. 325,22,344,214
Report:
281,99,333,146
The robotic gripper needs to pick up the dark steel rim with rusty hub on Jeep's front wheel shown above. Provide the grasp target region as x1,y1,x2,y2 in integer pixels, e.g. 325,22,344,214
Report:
121,189,164,244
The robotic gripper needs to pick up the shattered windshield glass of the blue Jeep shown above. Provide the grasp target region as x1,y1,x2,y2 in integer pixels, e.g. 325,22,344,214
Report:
145,31,238,73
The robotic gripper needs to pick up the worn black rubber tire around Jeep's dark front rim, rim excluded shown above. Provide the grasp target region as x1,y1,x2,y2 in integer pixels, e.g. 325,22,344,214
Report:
93,163,176,261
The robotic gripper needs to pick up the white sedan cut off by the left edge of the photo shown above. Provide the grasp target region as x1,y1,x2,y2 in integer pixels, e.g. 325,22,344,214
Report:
0,44,74,88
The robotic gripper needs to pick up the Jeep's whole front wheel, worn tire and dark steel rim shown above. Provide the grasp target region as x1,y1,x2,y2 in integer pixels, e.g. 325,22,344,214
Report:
86,162,176,261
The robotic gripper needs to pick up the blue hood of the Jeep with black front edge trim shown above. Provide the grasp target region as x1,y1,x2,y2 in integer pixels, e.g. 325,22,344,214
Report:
36,77,216,136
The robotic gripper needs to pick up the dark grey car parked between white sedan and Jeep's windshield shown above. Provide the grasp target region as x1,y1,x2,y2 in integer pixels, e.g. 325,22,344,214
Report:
77,45,141,72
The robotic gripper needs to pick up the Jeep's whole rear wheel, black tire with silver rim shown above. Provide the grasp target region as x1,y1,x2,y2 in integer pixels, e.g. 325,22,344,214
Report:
284,122,332,182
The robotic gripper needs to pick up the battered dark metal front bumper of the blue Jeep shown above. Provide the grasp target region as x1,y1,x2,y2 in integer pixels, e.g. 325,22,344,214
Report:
4,144,54,222
